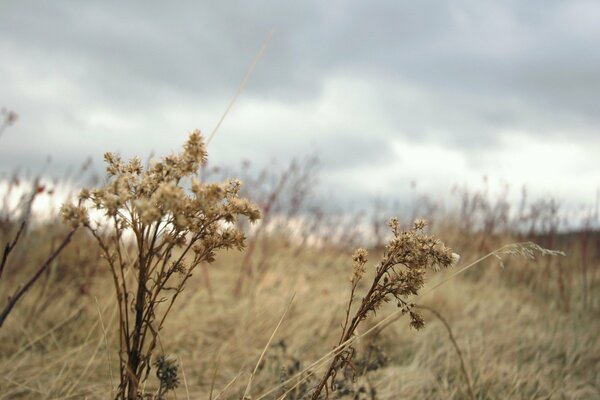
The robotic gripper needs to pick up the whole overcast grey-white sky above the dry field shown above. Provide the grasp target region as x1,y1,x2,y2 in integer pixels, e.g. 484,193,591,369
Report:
0,0,600,211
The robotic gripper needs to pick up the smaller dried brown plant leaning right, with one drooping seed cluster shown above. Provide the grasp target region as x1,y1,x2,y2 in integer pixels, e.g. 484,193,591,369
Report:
311,218,457,400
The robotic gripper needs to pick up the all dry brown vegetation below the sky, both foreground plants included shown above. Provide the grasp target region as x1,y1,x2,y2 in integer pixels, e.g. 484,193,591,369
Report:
0,129,600,400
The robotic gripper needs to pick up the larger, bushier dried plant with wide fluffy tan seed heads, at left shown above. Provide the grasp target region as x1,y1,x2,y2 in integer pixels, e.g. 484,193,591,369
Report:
61,131,260,399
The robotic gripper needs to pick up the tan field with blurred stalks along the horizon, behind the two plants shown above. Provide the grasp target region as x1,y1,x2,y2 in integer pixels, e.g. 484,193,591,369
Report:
0,130,600,400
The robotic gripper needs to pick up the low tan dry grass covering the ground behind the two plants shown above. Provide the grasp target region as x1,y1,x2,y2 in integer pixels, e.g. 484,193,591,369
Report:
0,220,600,399
